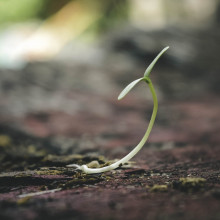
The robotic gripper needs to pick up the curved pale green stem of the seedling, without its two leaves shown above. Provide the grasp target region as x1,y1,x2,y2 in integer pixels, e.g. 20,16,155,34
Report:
80,77,158,174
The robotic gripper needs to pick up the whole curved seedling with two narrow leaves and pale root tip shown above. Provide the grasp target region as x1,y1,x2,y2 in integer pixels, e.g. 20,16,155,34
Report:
68,47,169,174
